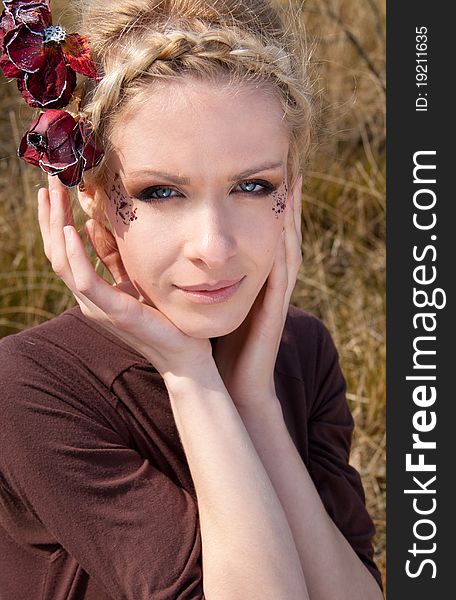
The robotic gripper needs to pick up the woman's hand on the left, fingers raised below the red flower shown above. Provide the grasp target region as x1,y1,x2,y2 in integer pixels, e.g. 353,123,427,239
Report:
38,176,213,376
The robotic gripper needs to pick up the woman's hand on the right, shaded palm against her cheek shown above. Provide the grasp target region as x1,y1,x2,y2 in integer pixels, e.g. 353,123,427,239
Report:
214,177,302,408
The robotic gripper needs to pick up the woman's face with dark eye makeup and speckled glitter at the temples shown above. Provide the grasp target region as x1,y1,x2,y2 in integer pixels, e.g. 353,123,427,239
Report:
91,79,289,338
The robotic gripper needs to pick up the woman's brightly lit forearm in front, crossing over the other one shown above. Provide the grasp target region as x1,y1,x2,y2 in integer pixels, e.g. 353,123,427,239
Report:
165,364,308,600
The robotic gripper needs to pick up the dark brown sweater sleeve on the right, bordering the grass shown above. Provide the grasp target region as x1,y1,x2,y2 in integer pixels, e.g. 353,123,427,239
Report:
308,319,382,588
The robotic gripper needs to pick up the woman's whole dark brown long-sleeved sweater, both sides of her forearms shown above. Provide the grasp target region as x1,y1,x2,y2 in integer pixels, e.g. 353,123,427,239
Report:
0,306,381,600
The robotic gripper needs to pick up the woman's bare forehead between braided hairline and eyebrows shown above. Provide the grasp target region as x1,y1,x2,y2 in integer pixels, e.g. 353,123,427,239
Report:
111,78,289,176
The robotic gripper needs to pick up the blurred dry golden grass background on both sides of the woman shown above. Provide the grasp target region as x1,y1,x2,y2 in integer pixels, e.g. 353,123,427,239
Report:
0,0,386,582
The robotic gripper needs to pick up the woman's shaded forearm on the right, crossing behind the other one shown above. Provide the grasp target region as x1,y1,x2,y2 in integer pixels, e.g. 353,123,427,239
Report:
239,398,383,600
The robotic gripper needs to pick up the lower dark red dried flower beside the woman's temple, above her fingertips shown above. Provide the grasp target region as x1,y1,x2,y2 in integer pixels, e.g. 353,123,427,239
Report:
18,109,103,187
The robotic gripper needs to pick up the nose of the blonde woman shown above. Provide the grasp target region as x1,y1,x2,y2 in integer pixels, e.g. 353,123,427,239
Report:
185,201,237,274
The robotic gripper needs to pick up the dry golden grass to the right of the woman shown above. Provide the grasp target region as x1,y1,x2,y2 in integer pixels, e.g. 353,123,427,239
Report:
293,0,386,581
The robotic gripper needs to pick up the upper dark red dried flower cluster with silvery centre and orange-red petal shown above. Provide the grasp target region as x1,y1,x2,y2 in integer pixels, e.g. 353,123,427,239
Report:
0,0,97,108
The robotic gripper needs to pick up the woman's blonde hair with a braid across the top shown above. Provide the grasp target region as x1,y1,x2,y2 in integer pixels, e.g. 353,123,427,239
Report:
76,0,312,190
